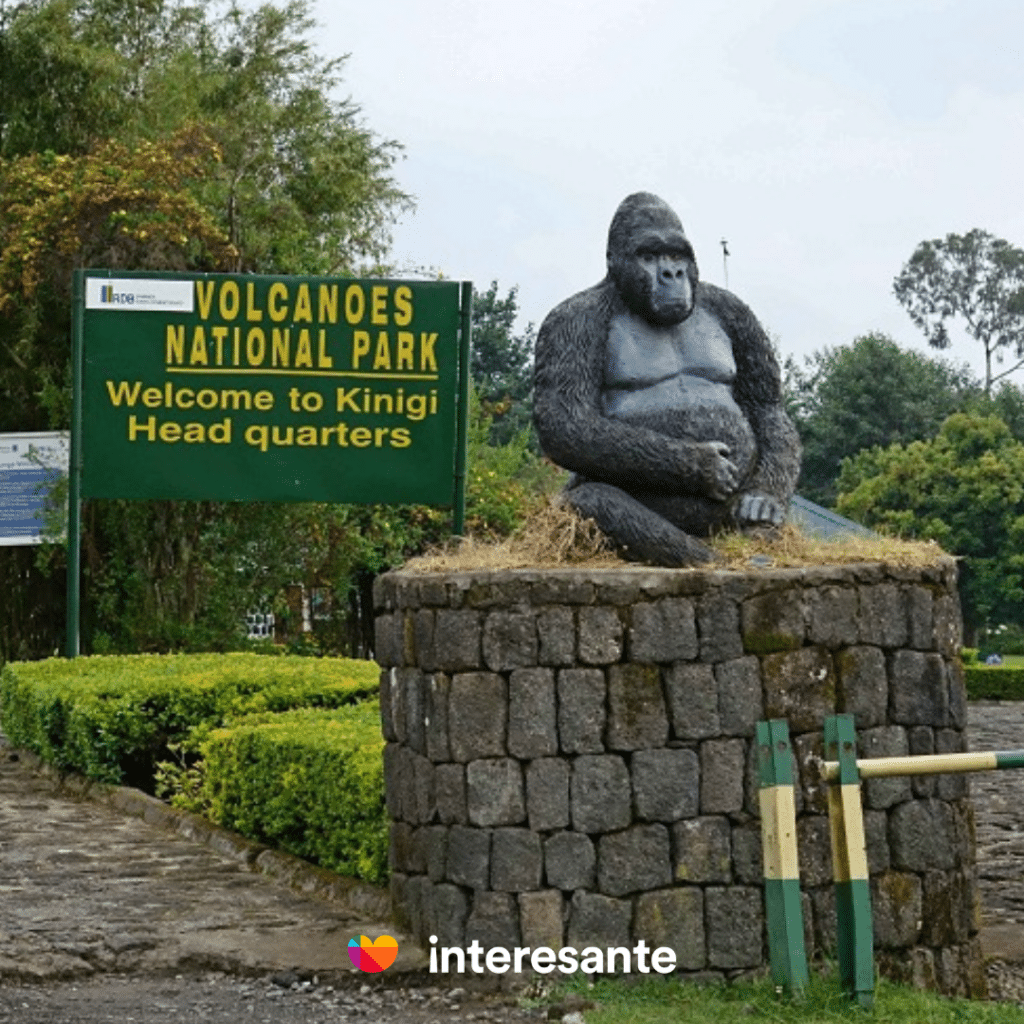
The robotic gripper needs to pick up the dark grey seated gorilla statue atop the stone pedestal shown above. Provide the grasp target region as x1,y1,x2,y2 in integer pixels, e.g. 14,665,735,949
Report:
534,193,800,565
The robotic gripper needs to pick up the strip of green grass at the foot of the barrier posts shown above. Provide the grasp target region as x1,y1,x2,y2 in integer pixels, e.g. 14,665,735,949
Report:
555,976,1024,1024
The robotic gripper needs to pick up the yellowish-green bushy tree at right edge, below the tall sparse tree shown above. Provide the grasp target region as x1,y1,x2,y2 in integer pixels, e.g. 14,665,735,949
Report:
837,414,1024,641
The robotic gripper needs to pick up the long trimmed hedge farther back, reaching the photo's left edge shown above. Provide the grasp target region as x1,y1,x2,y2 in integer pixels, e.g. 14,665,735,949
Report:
0,653,380,793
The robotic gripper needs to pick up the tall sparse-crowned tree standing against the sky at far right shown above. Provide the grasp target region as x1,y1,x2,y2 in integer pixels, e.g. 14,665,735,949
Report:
893,228,1024,394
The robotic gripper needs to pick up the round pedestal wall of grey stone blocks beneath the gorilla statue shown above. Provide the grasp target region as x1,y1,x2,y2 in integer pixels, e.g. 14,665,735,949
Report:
376,559,981,993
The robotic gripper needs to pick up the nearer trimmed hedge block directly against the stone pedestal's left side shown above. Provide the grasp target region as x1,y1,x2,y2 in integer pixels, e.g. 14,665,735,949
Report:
200,700,388,884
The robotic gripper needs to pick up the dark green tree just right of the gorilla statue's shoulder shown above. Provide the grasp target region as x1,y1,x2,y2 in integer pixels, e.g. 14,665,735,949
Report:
786,334,979,507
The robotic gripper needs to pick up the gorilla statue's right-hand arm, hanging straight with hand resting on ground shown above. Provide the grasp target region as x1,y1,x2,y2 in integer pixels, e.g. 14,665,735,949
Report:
700,283,801,525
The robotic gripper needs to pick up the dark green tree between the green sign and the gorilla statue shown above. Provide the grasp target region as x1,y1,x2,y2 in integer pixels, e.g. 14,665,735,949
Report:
470,281,535,445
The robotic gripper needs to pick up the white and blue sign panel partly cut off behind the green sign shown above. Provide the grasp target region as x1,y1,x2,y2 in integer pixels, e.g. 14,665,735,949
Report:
0,431,71,547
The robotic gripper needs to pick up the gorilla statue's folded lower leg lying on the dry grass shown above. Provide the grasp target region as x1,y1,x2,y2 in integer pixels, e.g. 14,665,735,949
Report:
563,483,719,568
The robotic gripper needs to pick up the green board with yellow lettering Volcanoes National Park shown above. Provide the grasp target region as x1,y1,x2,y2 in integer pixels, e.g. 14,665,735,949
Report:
78,270,471,506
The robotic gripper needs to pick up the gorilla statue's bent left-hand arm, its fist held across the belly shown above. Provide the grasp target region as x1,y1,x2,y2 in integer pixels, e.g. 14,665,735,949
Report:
534,279,737,501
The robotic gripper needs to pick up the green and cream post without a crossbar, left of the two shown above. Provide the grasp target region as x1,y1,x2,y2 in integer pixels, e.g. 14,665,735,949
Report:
757,720,808,995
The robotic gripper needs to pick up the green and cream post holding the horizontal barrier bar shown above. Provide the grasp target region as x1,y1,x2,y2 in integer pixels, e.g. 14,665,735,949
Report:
825,715,874,1010
